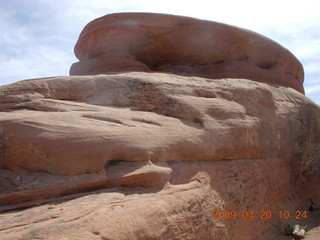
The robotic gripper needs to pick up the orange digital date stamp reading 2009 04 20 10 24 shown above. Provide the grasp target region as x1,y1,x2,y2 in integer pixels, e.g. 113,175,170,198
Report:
211,210,307,220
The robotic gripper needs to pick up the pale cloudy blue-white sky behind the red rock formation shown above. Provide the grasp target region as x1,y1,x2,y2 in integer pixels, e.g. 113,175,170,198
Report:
0,0,320,104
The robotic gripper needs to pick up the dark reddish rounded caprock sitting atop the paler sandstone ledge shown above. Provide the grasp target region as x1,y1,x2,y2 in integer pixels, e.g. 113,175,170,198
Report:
70,13,304,93
